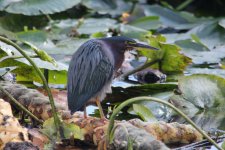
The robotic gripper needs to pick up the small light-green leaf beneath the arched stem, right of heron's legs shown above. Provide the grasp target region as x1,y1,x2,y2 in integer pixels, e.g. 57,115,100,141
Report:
133,104,157,121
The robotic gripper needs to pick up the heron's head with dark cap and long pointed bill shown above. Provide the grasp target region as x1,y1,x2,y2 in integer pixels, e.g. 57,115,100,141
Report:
102,36,158,53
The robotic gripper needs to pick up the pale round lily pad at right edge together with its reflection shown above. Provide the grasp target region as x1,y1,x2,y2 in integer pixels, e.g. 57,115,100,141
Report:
170,74,225,130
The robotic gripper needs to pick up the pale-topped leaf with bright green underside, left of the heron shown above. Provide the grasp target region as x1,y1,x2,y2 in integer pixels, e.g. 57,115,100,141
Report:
0,39,68,84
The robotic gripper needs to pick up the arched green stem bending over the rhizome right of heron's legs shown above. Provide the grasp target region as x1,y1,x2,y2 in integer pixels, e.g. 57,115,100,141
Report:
107,96,223,150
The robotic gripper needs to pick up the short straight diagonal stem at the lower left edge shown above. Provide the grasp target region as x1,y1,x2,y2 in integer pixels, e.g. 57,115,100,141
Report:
0,86,43,123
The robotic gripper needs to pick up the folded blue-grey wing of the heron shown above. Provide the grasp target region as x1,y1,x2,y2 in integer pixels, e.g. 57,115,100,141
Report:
68,41,113,112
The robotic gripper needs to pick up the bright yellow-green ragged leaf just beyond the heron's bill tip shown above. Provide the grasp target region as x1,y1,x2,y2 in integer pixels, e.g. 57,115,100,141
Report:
142,35,191,74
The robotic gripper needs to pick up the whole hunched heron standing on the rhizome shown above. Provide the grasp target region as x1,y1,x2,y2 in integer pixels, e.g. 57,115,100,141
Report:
67,36,157,118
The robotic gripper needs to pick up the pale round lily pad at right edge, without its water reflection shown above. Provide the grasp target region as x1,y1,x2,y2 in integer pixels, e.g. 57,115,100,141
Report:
171,74,225,109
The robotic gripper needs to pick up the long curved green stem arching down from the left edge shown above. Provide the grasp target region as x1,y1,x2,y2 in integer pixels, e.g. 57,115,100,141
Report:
0,36,64,138
